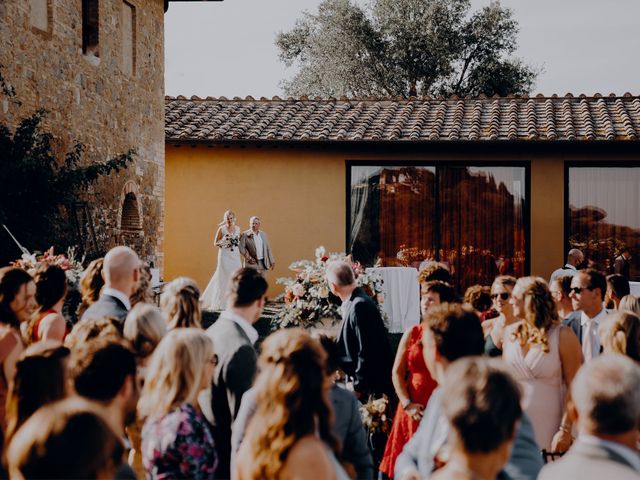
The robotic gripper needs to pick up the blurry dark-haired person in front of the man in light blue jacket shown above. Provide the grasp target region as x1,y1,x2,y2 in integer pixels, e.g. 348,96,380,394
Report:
432,357,522,480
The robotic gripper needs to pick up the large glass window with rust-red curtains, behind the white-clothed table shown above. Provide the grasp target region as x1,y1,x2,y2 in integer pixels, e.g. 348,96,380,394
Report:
348,163,527,289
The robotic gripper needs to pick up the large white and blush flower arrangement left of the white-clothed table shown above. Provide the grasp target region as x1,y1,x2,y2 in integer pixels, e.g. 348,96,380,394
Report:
274,246,384,328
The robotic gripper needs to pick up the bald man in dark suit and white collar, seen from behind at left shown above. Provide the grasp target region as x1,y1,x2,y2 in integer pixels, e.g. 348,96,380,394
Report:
81,246,140,327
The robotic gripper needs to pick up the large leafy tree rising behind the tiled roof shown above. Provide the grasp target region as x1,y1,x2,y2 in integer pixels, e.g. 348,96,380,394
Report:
276,0,539,98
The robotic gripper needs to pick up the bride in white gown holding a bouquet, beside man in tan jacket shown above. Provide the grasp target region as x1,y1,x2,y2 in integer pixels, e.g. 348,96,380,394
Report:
201,210,242,310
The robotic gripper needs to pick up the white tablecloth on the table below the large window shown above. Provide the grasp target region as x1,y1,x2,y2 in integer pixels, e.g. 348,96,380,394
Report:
367,267,420,333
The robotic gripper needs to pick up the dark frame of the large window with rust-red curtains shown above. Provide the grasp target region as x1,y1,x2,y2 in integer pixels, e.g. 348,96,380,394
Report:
344,159,531,276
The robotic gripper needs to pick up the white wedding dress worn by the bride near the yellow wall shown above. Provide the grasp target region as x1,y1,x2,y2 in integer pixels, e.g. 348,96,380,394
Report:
200,225,242,310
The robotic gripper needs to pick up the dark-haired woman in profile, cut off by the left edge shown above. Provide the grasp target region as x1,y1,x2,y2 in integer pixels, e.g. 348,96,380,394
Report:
0,267,37,425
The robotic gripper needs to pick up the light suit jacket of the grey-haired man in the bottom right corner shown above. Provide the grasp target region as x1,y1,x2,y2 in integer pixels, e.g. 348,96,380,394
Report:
538,439,640,480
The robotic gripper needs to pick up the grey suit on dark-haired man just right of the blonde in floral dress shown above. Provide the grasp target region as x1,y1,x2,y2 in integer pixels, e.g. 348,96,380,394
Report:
207,312,257,478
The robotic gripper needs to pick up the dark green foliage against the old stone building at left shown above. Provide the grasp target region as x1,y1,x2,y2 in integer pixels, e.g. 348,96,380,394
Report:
0,110,135,265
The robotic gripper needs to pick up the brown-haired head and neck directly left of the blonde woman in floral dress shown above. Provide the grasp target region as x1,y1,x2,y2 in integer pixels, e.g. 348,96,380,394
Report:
69,338,140,479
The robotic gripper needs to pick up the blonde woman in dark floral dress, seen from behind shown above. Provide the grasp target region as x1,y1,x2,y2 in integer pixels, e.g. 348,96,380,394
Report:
138,328,218,479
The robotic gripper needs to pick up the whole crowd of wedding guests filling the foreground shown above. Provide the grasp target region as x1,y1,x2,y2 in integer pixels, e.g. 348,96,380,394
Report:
0,247,640,480
